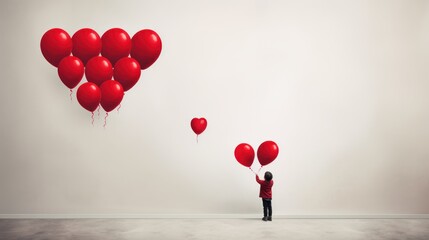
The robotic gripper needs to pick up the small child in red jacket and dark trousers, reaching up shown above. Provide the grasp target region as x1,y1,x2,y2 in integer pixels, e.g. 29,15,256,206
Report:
256,171,274,221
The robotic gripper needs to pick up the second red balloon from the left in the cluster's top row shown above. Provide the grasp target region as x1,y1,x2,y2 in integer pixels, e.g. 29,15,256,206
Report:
72,28,101,64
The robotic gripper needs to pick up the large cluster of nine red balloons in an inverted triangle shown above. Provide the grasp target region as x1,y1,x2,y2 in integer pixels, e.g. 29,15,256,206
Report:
40,28,162,119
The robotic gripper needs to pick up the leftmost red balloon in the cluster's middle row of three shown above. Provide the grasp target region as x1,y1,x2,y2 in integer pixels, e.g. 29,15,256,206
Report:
58,56,85,89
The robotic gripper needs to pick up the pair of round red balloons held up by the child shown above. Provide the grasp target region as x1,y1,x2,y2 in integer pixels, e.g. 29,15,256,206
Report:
234,141,279,168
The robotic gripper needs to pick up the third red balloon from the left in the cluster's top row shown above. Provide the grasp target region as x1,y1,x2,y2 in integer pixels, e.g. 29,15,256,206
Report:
101,28,131,65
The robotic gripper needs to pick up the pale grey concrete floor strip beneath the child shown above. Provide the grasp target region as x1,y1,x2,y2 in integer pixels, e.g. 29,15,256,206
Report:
0,219,429,240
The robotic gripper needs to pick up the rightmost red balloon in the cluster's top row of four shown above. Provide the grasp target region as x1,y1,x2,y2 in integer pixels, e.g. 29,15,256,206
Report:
131,29,162,69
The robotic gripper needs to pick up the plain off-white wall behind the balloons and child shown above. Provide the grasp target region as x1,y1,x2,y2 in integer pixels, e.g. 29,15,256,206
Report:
0,0,429,214
